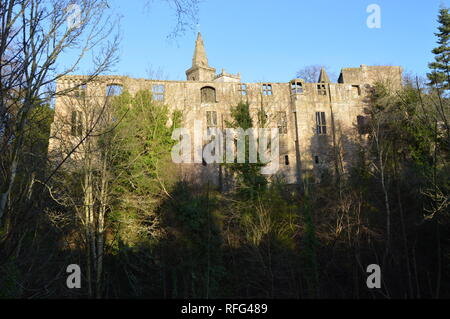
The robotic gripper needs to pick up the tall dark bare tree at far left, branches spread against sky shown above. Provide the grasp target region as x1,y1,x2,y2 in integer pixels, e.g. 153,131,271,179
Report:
0,0,119,228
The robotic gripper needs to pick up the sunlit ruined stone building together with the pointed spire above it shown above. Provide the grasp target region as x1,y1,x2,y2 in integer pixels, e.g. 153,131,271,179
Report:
50,33,402,184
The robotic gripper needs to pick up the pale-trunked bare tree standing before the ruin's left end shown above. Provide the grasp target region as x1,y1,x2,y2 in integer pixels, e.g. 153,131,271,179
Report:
44,80,119,298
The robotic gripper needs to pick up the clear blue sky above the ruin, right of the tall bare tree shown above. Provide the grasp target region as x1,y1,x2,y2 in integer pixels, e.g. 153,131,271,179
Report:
74,0,450,82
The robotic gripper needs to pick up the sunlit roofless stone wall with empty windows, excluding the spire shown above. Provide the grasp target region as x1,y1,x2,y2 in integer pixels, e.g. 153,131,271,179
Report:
50,66,401,188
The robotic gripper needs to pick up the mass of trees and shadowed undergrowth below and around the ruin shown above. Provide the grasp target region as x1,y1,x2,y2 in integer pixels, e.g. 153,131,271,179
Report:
0,1,450,298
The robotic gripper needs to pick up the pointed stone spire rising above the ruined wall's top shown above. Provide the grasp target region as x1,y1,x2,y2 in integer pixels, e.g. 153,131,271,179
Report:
186,32,216,81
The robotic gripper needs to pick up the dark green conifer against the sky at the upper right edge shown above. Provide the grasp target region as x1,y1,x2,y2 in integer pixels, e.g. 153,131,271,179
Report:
427,7,450,90
